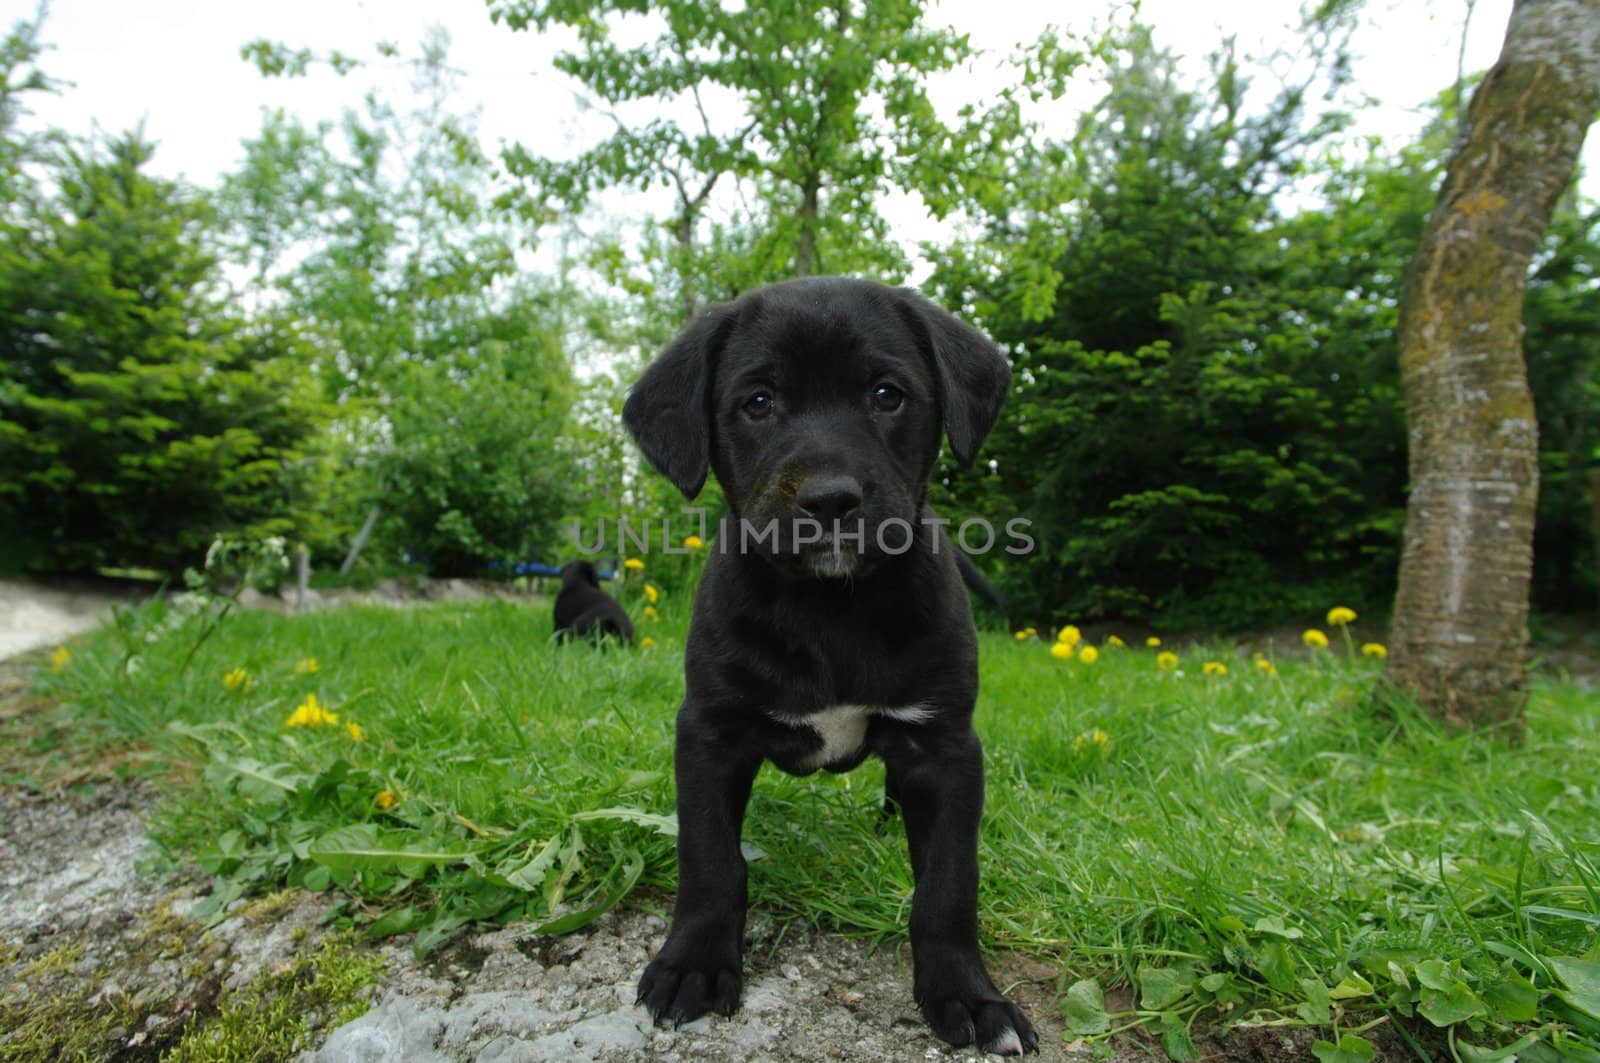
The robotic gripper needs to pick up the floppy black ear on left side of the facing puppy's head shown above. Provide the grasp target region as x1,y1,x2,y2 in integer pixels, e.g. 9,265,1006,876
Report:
622,307,733,498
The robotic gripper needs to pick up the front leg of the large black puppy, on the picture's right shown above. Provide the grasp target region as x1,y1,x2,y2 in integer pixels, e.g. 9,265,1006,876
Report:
885,728,1038,1055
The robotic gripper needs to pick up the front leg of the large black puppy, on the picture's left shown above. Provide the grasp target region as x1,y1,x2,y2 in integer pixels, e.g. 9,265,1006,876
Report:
638,704,762,1025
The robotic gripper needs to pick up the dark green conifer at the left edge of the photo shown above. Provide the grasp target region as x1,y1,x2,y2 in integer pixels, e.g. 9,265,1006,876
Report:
0,136,328,573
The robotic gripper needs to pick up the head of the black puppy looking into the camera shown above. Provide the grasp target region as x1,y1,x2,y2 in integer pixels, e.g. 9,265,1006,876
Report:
622,277,1011,578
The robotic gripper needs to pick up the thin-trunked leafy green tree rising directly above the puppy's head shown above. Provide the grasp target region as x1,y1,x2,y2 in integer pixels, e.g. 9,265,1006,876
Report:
490,0,976,299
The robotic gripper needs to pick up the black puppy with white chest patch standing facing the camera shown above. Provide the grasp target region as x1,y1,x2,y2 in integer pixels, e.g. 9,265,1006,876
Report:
622,277,1038,1053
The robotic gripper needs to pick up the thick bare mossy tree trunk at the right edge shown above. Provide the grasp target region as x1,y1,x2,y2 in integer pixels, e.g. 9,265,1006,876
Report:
1389,0,1600,725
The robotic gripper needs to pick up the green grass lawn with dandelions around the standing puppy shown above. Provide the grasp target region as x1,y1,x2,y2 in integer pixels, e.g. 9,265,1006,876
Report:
21,596,1600,1060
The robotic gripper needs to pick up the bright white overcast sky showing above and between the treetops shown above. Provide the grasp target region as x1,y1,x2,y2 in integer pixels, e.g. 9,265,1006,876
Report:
12,0,1600,264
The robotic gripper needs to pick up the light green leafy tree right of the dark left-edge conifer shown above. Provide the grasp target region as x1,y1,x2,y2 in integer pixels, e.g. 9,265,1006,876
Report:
219,35,573,576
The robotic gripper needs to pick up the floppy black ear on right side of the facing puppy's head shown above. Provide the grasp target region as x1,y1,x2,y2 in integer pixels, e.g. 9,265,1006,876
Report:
901,288,1011,469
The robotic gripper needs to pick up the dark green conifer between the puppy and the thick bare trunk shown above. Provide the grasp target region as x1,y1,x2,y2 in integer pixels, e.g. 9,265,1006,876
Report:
934,26,1382,628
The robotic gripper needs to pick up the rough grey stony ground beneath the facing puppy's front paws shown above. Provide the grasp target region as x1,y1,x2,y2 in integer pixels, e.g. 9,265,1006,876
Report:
306,911,1088,1063
